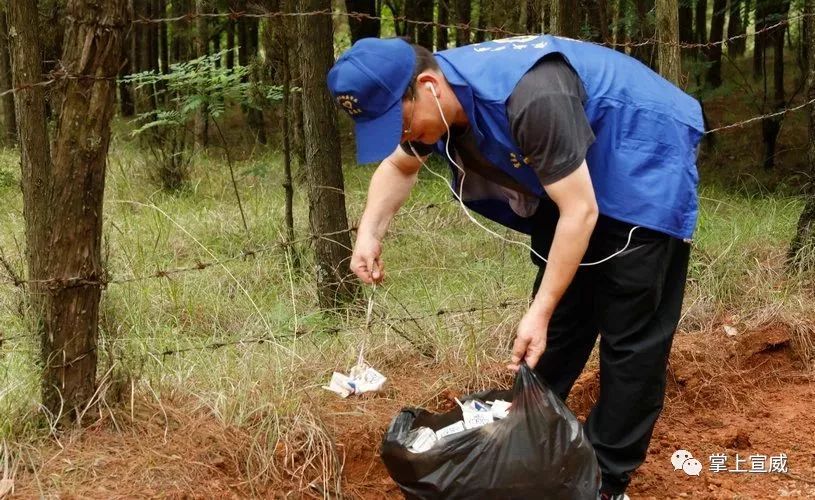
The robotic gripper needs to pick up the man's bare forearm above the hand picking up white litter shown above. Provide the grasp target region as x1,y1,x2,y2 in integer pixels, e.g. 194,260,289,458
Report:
359,160,417,240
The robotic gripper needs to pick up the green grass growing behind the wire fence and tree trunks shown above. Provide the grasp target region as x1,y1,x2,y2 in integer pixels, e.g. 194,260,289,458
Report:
0,118,811,451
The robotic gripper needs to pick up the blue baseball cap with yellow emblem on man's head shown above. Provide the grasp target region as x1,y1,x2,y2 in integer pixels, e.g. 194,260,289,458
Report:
328,38,416,163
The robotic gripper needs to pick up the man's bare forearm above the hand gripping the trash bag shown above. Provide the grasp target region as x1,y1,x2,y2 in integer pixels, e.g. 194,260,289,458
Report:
530,211,597,319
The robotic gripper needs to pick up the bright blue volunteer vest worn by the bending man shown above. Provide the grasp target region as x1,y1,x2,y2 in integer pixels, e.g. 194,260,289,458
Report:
435,35,704,239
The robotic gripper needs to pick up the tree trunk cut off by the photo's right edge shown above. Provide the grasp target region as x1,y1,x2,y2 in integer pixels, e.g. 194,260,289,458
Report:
787,0,815,271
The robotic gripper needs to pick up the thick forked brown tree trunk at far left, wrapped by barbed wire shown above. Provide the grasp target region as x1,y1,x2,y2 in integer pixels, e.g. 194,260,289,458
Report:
10,0,129,418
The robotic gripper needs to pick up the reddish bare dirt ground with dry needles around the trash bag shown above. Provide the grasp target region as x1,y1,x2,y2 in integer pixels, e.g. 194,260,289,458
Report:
7,324,815,499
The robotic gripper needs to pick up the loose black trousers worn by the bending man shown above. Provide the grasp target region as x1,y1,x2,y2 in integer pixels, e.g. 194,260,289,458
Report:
532,201,690,494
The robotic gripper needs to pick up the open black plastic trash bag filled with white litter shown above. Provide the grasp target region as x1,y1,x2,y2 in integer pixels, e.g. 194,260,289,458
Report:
380,364,600,500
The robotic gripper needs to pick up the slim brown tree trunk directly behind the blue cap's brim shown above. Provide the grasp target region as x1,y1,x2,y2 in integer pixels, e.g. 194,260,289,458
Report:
298,0,356,308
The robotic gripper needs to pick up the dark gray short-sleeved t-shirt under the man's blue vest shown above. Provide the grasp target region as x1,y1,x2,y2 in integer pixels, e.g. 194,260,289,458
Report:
402,54,594,188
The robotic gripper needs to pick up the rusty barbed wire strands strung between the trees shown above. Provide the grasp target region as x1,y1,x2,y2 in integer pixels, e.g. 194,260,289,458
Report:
0,9,815,355
